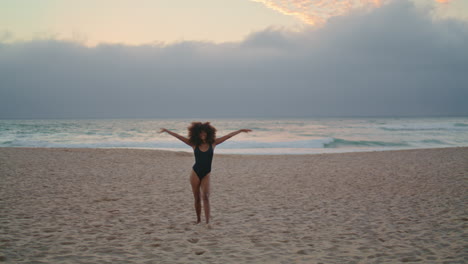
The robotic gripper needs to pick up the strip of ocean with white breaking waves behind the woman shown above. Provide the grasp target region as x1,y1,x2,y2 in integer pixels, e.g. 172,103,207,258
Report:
0,117,468,154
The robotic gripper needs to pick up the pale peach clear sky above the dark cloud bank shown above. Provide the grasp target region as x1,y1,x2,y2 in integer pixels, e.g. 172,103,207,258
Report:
0,0,468,46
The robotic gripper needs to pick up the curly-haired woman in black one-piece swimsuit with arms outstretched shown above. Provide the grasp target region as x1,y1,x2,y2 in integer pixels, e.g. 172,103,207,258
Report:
159,122,252,227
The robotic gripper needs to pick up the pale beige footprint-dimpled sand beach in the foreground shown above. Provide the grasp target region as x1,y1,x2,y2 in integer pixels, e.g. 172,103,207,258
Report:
0,148,468,263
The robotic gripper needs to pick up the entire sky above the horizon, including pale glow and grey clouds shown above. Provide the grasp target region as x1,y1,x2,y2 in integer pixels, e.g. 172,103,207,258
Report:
0,0,468,118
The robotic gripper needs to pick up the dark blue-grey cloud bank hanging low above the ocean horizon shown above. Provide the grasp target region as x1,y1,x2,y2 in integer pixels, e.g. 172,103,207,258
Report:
0,1,468,118
